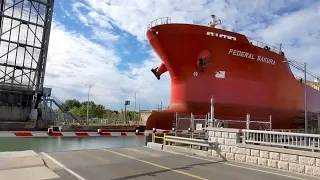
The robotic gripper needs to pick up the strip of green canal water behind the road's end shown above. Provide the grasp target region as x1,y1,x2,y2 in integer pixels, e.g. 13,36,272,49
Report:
0,136,146,152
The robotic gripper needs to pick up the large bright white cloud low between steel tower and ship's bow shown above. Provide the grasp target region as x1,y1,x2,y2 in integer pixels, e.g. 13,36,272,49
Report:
45,22,169,108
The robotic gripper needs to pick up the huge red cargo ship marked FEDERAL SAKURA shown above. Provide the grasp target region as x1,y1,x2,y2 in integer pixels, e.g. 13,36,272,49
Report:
146,15,320,129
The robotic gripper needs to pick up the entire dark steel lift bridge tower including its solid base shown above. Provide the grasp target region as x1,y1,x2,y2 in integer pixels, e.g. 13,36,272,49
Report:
0,0,54,126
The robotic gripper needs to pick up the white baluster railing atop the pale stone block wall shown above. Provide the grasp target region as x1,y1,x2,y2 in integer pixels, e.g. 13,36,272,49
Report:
242,129,320,150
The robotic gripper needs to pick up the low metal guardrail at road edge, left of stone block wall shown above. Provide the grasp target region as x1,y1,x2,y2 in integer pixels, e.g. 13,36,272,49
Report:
165,135,218,148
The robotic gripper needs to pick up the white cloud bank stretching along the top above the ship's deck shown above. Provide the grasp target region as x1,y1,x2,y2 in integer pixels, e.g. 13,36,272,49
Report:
75,0,320,69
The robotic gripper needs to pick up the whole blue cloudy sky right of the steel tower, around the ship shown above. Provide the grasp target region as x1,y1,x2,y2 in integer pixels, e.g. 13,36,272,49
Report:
39,0,320,110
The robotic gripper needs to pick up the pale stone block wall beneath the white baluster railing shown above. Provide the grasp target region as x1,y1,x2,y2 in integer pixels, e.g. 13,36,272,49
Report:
209,128,320,177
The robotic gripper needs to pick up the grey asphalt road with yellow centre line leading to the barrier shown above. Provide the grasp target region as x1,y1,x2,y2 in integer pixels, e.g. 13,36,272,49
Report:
41,147,317,180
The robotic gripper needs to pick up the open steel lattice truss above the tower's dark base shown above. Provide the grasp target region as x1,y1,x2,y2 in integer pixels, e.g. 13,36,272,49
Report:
0,0,54,94
